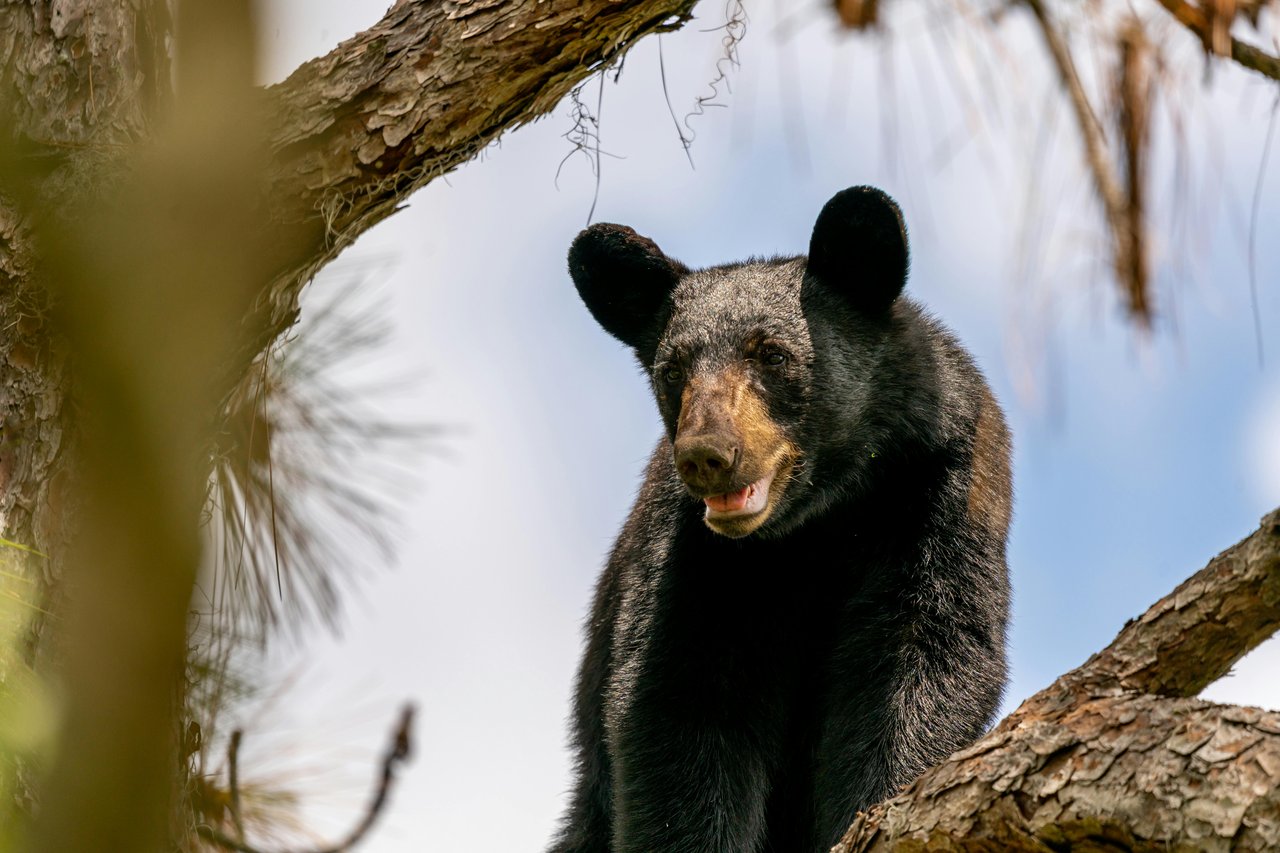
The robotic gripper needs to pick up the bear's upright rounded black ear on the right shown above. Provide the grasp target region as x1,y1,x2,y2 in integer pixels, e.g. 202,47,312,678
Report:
808,187,910,314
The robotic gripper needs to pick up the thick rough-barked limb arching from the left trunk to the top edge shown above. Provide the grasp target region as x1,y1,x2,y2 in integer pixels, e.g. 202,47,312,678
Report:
240,0,694,358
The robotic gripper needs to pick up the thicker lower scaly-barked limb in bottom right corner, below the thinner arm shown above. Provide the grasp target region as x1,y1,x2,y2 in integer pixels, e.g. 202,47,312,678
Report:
833,694,1280,853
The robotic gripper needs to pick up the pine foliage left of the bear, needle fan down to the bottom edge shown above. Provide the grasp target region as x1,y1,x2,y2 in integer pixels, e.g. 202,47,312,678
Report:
183,270,436,850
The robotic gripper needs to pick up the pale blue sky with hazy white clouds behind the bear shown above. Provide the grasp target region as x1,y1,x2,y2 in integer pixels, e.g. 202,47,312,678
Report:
227,0,1280,853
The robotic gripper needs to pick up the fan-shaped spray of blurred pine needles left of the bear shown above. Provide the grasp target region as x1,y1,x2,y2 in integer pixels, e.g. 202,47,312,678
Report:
196,281,419,640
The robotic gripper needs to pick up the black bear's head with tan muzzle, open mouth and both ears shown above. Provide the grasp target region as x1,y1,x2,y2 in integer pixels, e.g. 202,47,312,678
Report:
568,187,909,538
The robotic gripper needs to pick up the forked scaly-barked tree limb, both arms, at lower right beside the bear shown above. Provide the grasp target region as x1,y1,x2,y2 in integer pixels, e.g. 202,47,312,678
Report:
835,510,1280,853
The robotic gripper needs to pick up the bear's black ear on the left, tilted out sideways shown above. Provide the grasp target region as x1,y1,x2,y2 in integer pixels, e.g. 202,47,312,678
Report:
568,223,689,351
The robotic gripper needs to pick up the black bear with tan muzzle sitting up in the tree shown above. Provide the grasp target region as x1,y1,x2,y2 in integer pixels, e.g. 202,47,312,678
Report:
552,187,1011,853
